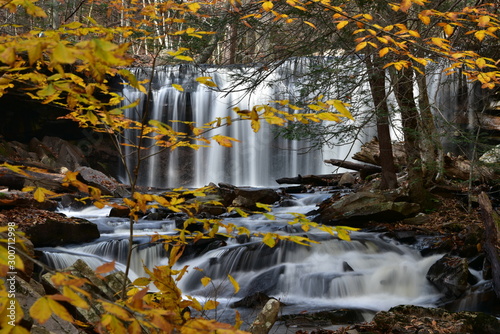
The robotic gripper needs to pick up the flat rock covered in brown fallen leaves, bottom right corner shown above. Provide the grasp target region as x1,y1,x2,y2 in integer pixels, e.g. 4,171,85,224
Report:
373,305,500,334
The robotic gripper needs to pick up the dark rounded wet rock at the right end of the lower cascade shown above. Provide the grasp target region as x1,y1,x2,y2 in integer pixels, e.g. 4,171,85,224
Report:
426,255,469,298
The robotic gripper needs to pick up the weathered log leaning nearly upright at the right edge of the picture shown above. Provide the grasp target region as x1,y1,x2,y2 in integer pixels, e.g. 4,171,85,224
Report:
479,192,500,298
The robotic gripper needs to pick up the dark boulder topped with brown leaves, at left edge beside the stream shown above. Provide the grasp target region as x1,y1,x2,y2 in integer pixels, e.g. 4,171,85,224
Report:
2,208,100,247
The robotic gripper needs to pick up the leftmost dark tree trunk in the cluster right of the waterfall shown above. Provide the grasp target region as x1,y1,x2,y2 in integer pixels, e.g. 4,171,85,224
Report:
366,56,398,190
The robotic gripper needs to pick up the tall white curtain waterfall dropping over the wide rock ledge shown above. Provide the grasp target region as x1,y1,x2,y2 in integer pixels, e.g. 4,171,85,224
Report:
121,58,374,188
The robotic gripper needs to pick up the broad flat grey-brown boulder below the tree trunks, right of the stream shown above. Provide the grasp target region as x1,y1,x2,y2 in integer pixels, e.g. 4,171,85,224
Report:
315,192,420,226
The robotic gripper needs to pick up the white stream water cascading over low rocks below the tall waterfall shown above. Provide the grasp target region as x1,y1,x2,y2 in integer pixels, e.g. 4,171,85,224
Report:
43,194,441,321
